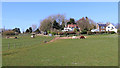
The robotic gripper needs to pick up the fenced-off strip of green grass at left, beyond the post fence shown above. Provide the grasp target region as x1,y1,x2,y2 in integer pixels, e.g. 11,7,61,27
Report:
2,35,53,51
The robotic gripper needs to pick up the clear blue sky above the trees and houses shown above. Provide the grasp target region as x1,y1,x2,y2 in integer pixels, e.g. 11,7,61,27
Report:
2,2,118,31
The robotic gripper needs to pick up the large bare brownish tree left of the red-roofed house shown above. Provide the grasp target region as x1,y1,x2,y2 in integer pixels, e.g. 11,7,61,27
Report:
39,14,66,31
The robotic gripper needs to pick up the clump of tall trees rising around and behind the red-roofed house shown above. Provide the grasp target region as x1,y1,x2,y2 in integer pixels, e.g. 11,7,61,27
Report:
39,14,96,31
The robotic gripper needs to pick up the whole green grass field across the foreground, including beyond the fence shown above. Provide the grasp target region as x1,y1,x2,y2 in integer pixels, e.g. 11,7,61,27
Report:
3,34,118,66
